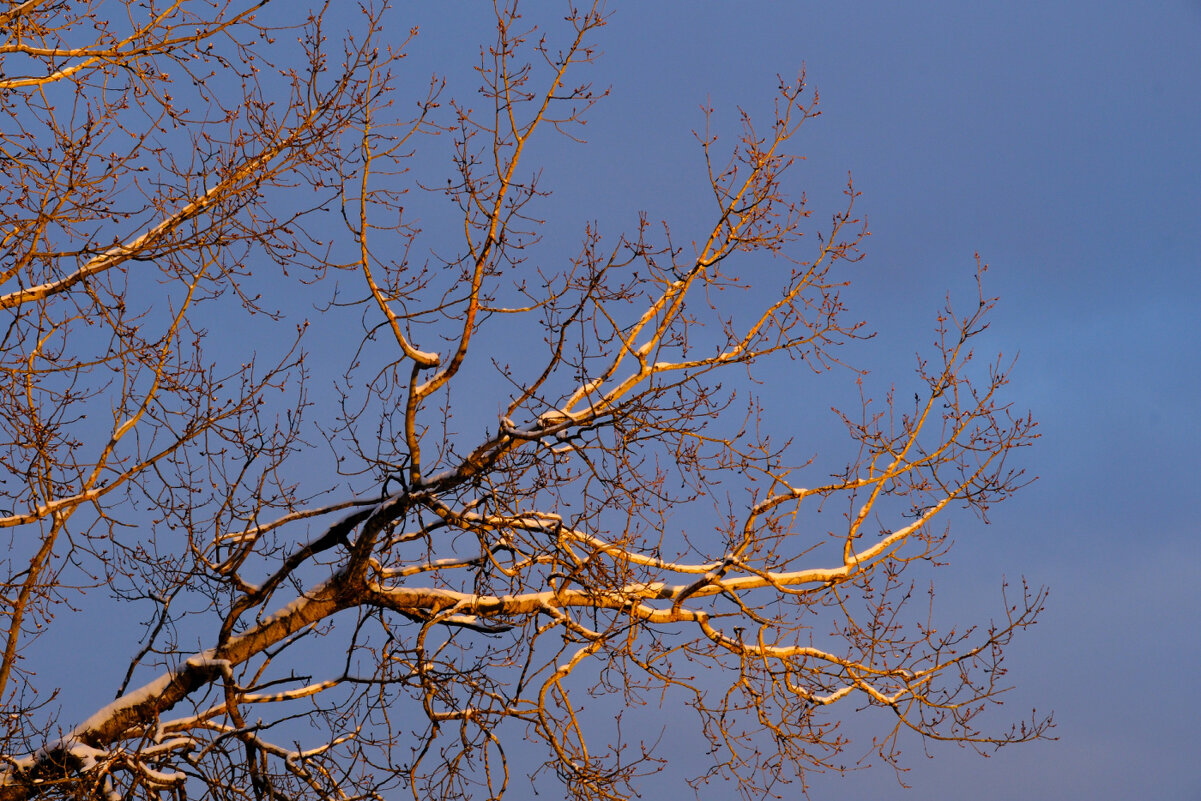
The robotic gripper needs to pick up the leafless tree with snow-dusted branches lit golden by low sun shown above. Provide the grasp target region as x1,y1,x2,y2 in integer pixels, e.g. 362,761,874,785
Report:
0,0,1048,799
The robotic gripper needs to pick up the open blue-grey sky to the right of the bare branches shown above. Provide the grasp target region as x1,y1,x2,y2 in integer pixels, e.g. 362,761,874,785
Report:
386,0,1201,801
